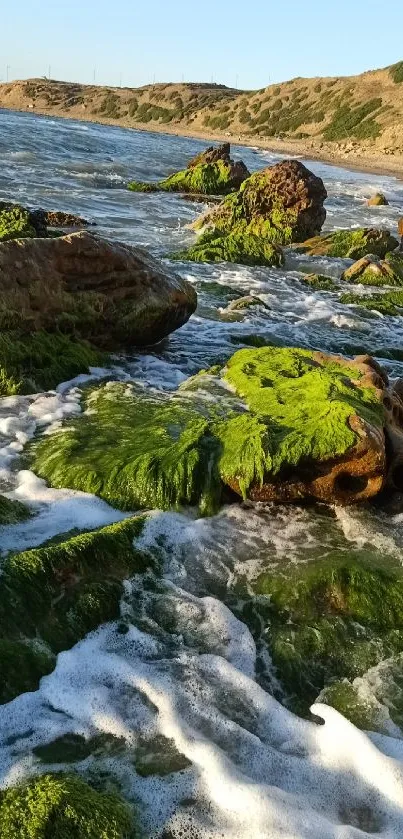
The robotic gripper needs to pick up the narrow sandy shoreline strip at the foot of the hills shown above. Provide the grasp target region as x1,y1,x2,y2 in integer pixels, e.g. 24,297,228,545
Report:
0,106,403,180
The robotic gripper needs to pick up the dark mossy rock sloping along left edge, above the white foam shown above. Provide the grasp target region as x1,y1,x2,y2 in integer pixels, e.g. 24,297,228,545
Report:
0,517,151,702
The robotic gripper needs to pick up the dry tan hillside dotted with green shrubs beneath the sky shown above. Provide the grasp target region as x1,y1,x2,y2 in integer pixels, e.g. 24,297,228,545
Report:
0,62,403,171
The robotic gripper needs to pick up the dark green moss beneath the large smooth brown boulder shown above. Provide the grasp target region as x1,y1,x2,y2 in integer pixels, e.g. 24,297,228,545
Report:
0,332,107,396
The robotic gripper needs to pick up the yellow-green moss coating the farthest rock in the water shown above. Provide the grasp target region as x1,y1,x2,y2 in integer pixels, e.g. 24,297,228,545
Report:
128,160,241,195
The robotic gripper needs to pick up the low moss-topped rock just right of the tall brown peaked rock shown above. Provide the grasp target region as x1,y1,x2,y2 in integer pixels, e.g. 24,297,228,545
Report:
294,227,398,259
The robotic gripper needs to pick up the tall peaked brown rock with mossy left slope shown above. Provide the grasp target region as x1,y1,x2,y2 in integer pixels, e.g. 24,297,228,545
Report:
194,160,327,245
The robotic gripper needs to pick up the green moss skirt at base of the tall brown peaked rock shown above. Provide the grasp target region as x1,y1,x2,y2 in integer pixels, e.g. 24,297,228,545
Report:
170,230,284,267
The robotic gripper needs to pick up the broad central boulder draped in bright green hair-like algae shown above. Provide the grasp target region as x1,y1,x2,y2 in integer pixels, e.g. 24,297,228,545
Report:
31,347,385,513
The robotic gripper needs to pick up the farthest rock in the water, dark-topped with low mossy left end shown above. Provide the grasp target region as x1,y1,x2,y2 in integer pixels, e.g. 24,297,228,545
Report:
128,143,250,196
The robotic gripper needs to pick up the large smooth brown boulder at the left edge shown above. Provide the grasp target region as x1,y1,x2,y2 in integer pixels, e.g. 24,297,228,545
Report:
0,232,197,349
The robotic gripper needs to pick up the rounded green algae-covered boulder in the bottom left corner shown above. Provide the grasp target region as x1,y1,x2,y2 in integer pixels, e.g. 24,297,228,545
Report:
0,774,139,839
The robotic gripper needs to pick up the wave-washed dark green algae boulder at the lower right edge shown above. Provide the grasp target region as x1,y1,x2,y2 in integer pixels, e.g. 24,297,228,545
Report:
251,551,403,721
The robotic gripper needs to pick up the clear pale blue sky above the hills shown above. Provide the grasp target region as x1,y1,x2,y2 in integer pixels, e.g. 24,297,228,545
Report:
0,0,403,89
